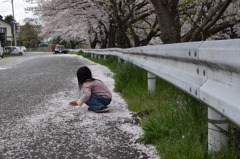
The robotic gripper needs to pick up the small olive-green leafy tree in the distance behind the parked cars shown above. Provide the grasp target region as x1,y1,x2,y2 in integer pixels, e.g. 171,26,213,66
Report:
17,18,42,48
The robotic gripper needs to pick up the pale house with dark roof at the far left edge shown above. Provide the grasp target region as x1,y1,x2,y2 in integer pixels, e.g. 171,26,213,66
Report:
0,19,13,46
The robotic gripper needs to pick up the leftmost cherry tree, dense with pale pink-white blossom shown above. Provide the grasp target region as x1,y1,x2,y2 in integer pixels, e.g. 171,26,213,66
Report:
30,0,92,48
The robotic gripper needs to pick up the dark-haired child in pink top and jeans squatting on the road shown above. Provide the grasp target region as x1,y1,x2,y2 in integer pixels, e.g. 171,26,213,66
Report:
69,66,112,113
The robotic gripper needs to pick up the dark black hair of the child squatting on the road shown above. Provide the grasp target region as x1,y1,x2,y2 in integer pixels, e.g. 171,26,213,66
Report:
77,66,95,88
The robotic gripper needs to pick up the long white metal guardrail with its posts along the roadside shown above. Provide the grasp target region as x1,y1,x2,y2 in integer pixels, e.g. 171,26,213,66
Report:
70,39,240,151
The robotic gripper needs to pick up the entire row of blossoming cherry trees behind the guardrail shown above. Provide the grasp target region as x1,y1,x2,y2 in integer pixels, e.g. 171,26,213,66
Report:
27,0,240,48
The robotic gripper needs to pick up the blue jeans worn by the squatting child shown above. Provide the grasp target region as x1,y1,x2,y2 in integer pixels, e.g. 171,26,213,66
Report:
85,94,112,111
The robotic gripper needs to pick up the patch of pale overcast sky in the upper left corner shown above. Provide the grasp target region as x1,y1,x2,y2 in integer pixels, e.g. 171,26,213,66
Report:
0,0,36,24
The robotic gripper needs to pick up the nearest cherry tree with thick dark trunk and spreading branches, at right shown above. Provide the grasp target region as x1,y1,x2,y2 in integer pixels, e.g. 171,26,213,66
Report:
151,0,240,43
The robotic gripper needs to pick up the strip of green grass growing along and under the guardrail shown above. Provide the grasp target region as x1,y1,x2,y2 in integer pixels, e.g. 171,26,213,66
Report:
71,52,240,159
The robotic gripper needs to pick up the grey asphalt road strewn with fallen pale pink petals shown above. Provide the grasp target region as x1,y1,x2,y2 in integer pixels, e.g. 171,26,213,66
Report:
0,53,159,159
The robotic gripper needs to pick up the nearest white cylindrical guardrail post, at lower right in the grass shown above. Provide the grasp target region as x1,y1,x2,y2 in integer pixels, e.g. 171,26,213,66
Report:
208,107,228,152
